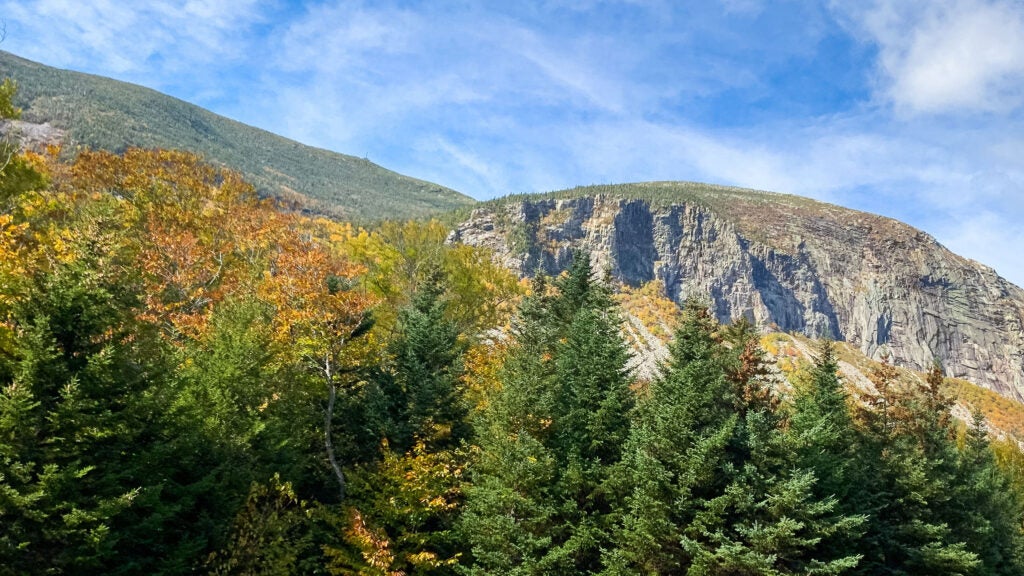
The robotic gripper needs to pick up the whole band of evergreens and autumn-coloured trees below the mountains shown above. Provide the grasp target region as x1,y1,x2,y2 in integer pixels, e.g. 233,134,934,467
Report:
0,145,1024,576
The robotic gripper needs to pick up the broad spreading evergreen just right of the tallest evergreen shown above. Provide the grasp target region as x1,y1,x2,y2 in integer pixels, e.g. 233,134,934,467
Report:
606,309,862,574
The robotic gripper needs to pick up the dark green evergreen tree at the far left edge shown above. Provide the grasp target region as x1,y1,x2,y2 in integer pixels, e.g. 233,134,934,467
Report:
0,251,166,574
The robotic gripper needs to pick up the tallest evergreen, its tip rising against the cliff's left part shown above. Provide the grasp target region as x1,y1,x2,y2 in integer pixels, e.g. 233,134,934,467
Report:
462,254,634,574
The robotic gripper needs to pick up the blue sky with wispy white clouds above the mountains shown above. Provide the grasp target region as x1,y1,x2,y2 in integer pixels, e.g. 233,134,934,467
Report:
6,0,1024,286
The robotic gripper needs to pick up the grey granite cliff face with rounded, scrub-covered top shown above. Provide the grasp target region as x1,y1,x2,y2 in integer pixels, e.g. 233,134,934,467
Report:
453,182,1024,401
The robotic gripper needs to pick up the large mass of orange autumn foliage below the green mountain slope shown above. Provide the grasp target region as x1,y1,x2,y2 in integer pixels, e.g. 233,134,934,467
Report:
7,150,370,338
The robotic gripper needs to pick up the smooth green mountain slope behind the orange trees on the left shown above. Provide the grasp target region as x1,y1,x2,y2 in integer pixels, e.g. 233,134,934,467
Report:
0,51,474,220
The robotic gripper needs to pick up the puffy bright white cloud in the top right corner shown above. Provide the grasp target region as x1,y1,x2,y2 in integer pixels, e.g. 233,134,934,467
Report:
839,0,1024,114
